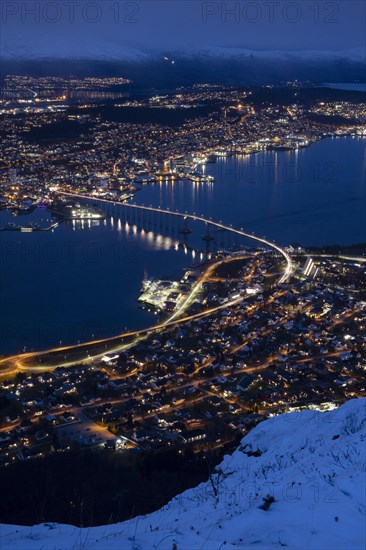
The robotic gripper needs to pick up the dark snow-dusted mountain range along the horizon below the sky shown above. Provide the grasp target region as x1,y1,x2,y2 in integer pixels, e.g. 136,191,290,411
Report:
0,40,366,88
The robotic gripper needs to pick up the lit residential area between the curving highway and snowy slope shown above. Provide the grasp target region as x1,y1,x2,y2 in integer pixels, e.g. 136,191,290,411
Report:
0,250,366,465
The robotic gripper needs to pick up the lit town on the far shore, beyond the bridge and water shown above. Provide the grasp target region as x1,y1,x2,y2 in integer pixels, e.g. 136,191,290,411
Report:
0,81,366,215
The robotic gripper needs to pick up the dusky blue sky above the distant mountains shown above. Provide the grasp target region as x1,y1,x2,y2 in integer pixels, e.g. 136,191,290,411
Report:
1,0,366,56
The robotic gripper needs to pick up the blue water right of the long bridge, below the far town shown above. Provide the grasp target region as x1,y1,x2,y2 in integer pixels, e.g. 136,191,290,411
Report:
137,137,366,245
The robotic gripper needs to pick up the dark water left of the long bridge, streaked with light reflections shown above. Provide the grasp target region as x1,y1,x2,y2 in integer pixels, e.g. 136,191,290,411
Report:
0,210,210,354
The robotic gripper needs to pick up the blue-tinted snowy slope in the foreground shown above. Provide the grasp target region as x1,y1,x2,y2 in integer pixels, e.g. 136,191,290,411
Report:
0,399,366,550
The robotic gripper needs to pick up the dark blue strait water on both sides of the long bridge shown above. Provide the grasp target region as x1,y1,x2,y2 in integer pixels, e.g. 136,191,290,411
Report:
0,138,366,354
